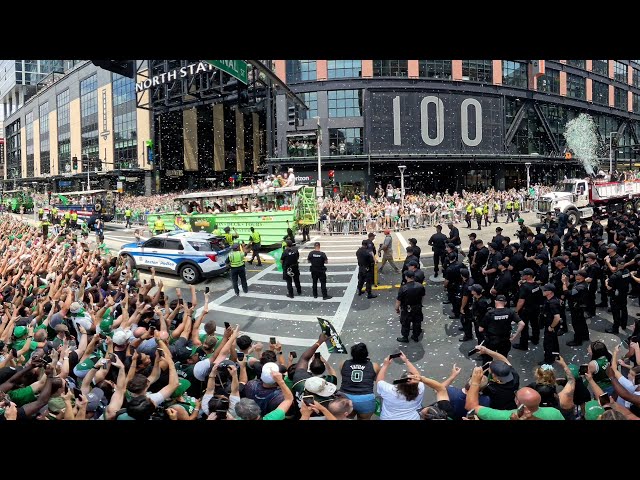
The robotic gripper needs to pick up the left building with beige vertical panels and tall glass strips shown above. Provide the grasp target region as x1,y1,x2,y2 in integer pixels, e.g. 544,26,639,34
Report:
2,60,152,195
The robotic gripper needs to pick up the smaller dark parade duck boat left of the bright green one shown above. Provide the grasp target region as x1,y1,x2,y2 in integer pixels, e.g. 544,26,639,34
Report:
46,190,115,225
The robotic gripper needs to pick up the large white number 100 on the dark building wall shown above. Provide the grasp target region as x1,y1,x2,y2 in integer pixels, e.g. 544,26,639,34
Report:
393,95,482,147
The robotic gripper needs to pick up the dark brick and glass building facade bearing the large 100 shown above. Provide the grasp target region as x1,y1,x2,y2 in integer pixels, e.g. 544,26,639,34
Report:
268,60,640,192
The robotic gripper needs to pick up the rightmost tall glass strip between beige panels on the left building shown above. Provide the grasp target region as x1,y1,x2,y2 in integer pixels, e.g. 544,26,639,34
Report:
112,73,138,169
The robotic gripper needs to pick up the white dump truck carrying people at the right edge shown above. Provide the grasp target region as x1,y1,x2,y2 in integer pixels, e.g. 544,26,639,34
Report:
534,178,640,223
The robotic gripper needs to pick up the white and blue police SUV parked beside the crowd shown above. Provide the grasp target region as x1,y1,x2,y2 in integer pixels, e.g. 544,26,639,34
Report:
118,230,231,284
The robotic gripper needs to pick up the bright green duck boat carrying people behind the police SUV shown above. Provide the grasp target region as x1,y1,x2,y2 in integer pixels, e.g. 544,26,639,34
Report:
147,185,318,249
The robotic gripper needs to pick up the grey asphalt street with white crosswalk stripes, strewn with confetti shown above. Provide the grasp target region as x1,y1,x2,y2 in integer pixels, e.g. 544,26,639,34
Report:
16,213,640,401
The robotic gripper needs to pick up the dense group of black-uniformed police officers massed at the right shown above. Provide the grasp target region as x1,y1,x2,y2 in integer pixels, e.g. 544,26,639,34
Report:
430,215,640,363
